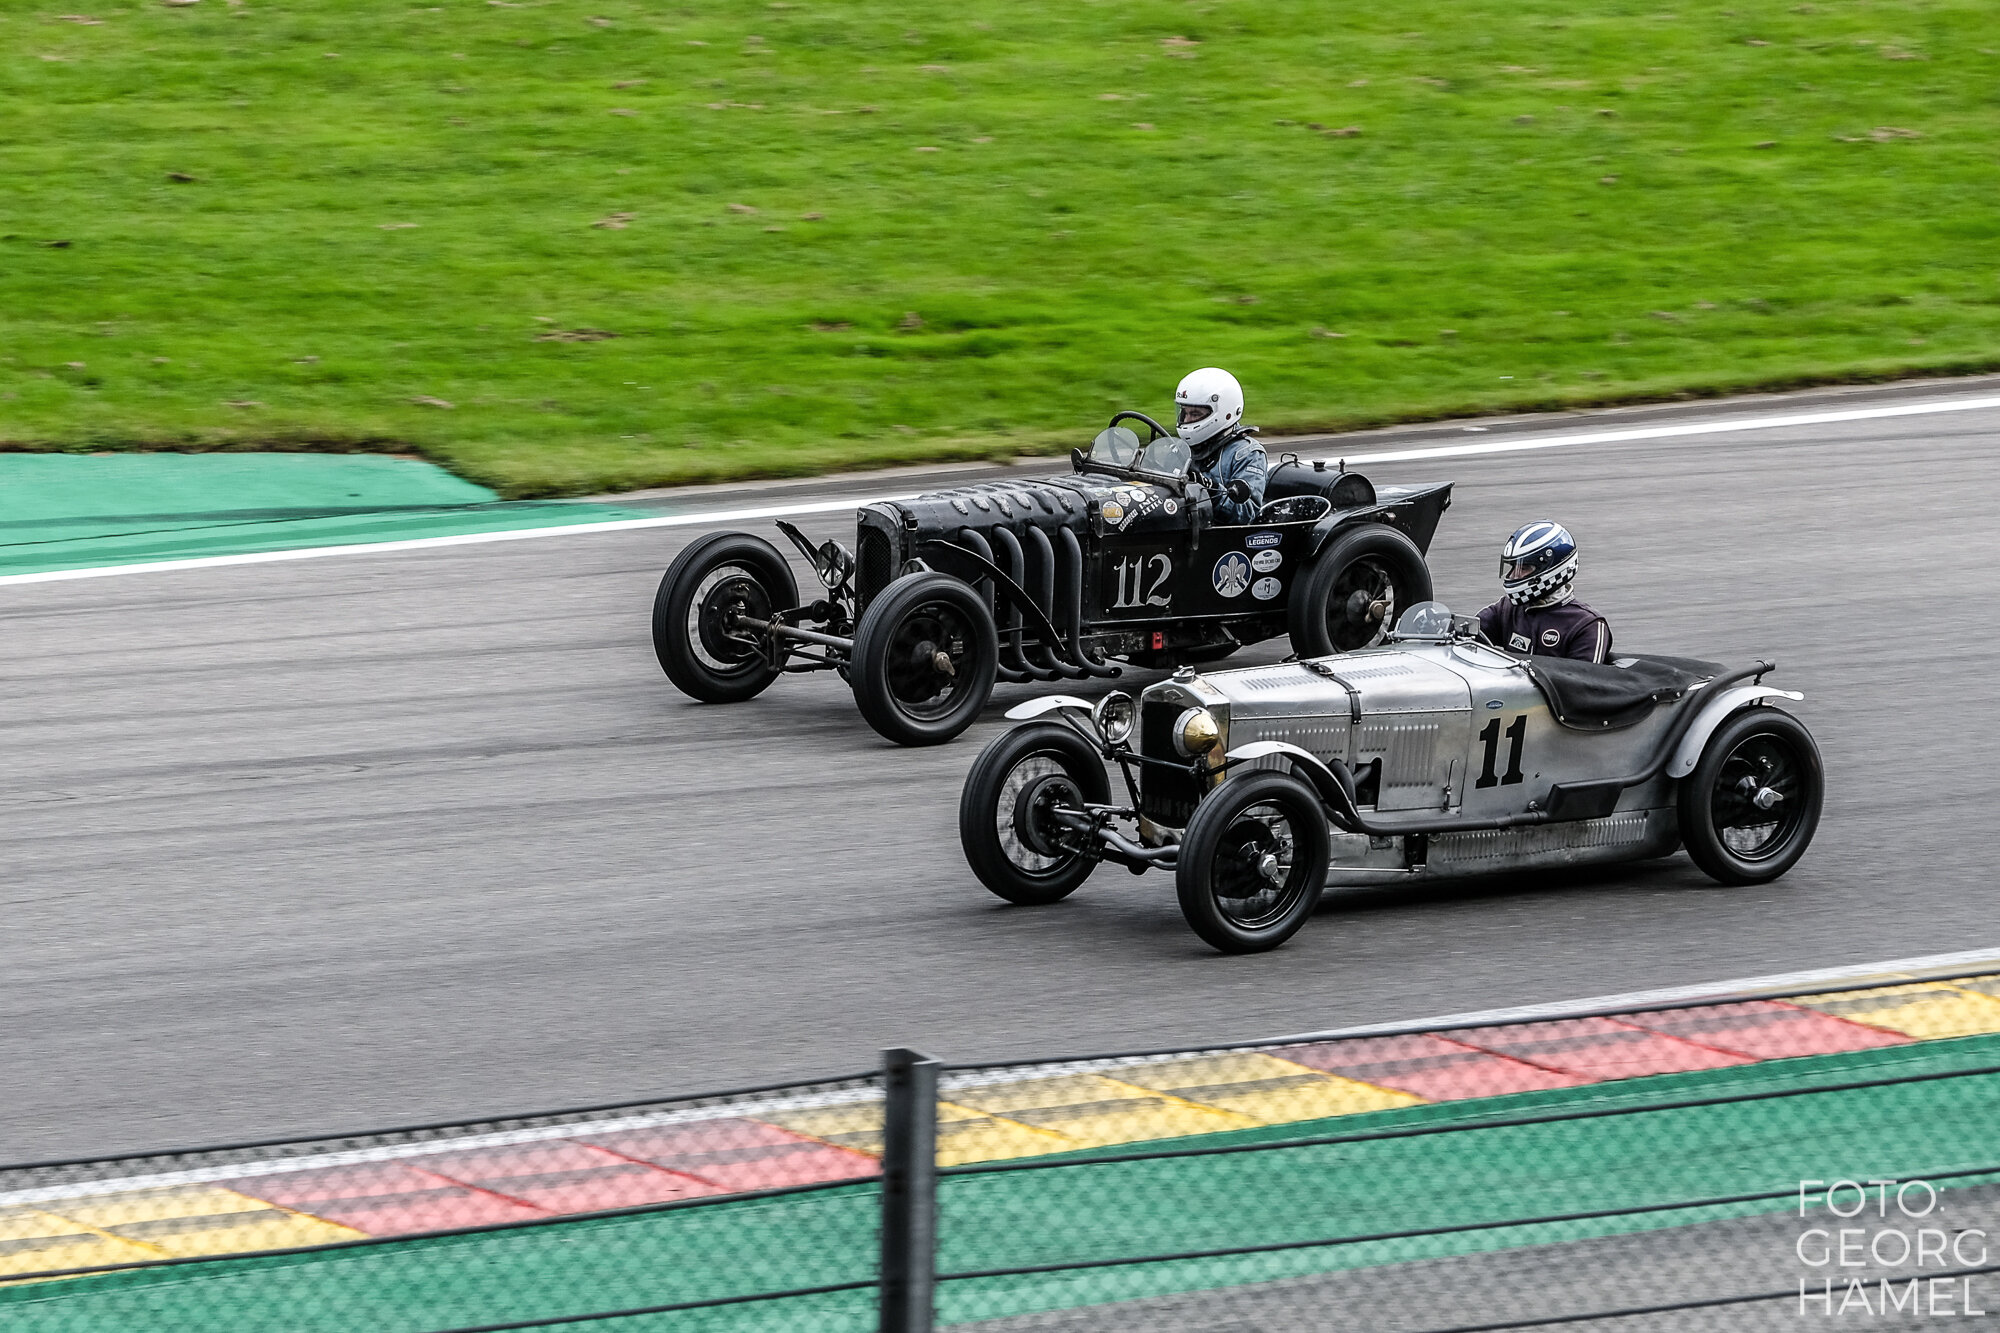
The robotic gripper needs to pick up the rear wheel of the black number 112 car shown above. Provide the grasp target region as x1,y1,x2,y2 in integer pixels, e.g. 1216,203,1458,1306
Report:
1286,522,1430,656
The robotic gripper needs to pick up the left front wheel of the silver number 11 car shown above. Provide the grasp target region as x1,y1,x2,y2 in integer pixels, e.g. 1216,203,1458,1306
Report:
958,723,1112,907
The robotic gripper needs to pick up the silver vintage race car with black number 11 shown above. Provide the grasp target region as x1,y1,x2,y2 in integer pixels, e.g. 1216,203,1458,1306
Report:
958,602,1826,953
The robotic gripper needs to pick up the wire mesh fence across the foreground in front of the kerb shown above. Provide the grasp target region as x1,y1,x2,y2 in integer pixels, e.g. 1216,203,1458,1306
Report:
0,964,2000,1333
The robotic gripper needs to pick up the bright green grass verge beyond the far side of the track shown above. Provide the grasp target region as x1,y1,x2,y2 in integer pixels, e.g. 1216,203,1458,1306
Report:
0,0,2000,496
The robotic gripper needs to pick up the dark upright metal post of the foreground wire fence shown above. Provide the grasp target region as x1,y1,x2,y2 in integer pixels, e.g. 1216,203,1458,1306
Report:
880,1047,938,1333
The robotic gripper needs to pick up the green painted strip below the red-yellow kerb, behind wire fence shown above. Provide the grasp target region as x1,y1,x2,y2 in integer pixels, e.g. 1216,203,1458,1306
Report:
11,1037,2000,1333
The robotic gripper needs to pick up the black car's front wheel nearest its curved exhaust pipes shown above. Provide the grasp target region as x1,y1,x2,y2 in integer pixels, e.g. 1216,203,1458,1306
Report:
850,572,1000,745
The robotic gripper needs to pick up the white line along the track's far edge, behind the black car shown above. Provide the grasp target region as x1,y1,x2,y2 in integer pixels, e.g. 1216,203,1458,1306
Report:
11,396,2000,584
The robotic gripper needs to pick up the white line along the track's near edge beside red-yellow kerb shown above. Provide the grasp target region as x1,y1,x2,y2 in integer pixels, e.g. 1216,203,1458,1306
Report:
0,932,2000,1207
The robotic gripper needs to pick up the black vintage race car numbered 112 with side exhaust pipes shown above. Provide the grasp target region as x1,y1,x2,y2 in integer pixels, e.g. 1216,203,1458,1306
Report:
652,412,1452,745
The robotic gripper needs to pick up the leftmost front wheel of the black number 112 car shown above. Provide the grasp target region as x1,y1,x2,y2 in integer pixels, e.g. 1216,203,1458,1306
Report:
652,532,798,703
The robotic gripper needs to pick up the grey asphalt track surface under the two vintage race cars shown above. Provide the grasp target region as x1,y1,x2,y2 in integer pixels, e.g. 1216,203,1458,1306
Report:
0,380,2000,1161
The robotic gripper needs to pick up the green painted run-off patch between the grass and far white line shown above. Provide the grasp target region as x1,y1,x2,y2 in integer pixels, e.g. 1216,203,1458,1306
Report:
0,454,644,574
